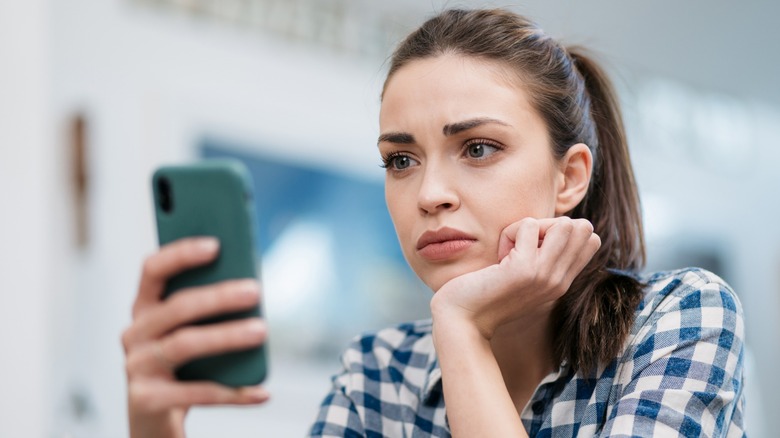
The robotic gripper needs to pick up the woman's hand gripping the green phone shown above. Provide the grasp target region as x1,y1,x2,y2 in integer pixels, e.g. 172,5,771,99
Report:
122,238,268,437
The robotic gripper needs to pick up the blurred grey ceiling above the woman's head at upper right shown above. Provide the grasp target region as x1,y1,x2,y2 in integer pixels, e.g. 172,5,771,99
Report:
396,0,780,106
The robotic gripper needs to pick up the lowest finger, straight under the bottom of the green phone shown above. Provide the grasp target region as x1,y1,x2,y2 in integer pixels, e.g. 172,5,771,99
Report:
128,379,270,413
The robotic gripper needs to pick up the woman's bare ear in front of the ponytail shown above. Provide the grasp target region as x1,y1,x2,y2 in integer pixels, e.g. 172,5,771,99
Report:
555,143,593,216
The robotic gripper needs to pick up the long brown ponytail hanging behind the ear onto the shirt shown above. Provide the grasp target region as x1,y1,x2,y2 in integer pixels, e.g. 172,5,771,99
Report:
553,48,645,372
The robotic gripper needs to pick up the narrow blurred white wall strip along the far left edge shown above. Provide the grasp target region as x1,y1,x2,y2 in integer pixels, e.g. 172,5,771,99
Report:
0,0,59,436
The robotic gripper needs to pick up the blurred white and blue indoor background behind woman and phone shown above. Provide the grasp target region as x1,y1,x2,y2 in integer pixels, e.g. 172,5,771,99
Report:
0,0,780,438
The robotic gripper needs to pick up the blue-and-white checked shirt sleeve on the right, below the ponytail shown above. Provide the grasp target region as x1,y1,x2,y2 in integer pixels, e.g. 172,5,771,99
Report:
602,272,744,437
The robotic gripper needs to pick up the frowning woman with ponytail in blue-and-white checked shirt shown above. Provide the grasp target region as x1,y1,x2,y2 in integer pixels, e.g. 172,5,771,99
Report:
123,10,744,437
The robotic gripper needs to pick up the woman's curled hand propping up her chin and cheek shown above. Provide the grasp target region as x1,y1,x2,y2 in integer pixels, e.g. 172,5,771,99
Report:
431,216,601,339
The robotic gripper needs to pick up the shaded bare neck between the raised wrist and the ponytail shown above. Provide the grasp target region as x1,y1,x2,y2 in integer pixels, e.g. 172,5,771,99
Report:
490,314,558,412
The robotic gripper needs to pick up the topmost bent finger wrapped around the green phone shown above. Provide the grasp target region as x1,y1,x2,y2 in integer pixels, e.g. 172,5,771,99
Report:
133,237,219,317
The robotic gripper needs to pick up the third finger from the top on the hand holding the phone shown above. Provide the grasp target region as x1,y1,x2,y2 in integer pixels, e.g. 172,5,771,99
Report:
160,318,267,366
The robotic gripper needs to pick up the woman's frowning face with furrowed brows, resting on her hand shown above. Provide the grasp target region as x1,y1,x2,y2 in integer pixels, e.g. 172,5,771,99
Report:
379,55,564,291
